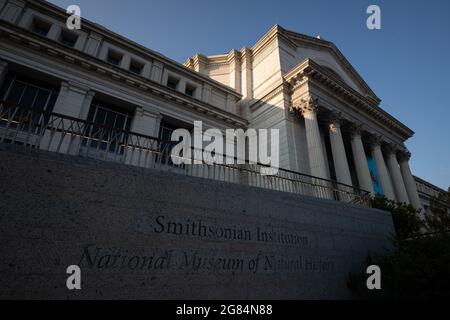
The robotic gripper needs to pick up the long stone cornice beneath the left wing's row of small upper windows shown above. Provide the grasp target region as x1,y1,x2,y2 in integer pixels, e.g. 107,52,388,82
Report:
0,21,248,127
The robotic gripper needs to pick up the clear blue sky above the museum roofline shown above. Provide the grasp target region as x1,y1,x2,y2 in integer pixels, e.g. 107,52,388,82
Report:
51,0,450,189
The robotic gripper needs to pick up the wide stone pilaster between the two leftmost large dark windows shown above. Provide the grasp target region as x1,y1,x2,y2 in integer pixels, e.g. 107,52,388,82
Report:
40,82,94,155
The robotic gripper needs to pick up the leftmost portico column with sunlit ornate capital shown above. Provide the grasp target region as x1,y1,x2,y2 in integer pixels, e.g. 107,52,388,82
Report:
301,96,327,179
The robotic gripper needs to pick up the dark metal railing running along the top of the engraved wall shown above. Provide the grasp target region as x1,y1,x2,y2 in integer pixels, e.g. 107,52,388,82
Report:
0,101,370,205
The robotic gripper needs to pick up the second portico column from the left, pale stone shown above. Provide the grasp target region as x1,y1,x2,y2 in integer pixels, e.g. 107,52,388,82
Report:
328,116,352,186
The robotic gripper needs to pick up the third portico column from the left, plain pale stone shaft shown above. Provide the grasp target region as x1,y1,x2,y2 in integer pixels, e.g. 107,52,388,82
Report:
351,128,374,195
